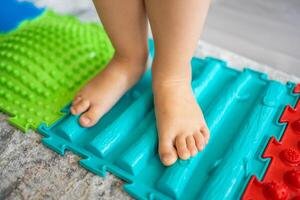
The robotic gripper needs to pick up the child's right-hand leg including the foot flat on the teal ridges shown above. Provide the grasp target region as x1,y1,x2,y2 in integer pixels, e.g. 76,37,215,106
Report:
145,0,209,165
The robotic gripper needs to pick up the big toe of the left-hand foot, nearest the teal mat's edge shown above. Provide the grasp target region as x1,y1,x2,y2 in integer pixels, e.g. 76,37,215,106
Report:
79,105,103,127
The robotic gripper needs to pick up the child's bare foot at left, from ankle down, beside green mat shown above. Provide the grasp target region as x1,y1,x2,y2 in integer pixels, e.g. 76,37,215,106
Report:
70,54,147,127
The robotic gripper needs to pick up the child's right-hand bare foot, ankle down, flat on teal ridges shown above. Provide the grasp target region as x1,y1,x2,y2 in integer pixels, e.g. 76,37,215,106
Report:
153,77,209,166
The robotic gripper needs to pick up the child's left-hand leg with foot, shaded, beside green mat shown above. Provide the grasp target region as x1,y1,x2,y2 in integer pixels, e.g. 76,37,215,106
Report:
71,0,148,127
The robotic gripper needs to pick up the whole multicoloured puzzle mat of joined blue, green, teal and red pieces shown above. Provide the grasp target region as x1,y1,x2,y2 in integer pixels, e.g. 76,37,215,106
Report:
0,1,300,200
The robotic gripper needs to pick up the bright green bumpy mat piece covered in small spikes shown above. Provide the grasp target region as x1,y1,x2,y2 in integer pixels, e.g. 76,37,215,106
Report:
0,11,114,132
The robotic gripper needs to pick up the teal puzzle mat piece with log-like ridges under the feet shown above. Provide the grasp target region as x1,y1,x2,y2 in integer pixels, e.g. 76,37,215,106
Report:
38,58,298,199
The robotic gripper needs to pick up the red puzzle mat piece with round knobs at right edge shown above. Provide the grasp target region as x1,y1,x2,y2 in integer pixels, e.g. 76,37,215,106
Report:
242,84,300,200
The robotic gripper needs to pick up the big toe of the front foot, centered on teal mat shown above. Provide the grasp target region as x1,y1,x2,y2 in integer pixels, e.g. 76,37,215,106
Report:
158,138,177,166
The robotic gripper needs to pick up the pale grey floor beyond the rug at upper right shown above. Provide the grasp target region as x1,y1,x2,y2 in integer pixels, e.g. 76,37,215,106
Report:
202,0,300,76
